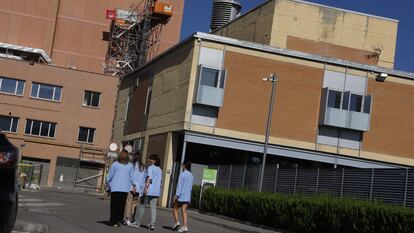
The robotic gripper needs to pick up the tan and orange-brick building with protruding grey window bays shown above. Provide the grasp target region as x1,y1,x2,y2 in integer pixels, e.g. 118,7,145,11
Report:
114,0,414,205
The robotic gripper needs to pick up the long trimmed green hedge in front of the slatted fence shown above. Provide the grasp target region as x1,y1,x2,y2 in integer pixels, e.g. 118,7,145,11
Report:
199,188,414,233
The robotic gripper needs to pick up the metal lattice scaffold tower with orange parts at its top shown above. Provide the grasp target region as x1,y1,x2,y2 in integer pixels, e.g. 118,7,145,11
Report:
104,0,172,76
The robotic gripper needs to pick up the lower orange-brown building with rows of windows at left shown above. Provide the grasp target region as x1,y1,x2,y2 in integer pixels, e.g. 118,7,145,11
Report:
0,58,118,187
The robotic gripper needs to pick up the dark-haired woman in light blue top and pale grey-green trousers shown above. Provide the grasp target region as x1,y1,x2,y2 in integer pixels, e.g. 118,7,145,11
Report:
132,154,162,230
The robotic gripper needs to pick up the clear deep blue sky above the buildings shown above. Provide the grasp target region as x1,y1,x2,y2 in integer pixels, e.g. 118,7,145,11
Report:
181,0,414,72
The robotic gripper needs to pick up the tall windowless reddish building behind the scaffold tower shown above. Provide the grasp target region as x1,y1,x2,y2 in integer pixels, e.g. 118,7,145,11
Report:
0,0,184,73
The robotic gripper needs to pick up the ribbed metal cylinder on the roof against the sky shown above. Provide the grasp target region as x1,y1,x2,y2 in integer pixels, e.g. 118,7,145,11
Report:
210,0,242,31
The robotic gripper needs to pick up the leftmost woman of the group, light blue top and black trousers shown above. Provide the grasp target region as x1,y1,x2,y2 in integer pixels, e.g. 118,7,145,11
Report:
106,150,133,227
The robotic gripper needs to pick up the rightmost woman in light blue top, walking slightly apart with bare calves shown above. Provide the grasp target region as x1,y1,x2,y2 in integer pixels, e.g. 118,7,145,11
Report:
173,162,193,232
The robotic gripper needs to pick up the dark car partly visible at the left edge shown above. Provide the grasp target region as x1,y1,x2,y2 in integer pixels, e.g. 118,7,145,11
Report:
0,130,19,233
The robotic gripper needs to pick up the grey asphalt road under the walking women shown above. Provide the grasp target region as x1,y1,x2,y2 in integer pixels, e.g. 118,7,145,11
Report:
18,192,278,233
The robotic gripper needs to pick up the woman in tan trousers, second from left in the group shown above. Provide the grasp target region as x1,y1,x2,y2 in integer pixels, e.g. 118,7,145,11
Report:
124,151,146,226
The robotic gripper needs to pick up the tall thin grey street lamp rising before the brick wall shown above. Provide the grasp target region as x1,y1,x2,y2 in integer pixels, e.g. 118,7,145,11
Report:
259,73,278,192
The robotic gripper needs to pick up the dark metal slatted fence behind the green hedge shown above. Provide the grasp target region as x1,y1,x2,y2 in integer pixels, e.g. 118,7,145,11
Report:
214,165,414,207
